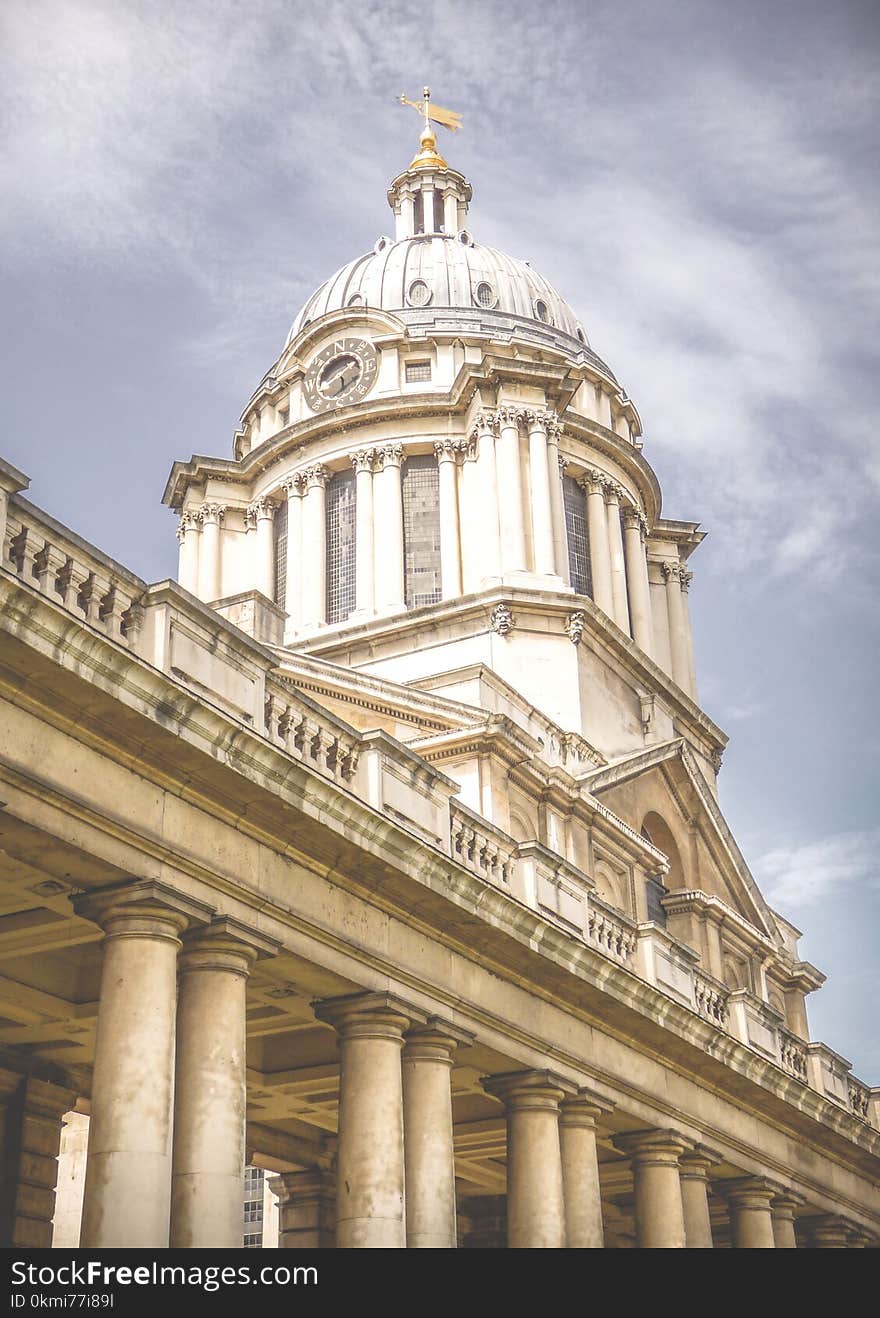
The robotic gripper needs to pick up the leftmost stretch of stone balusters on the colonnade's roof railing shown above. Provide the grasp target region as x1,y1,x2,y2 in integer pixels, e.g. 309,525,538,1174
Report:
3,497,145,646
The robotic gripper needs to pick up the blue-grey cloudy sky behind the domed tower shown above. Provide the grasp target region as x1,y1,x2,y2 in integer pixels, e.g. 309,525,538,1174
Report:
0,0,880,1083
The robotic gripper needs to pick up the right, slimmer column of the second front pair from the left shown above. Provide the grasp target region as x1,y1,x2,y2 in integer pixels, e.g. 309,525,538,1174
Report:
403,1020,470,1249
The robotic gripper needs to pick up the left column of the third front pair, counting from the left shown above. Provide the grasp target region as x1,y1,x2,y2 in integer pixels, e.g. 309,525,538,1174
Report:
482,1070,574,1249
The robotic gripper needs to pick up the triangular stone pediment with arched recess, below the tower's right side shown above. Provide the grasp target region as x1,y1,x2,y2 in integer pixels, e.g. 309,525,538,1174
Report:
581,738,780,945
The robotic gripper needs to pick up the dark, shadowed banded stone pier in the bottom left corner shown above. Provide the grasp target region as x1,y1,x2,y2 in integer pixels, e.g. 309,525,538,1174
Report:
0,1069,76,1249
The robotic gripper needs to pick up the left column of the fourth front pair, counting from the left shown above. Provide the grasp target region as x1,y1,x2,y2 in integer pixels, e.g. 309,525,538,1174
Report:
614,1131,690,1249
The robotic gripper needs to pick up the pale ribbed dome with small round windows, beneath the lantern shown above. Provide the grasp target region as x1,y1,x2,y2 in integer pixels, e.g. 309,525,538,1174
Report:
287,229,588,352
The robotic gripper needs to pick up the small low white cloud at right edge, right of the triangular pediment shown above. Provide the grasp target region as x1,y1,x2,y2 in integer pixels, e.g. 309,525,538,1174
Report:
752,829,880,908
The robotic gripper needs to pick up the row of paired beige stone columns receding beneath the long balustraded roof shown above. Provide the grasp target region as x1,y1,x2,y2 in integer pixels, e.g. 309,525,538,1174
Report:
60,880,868,1248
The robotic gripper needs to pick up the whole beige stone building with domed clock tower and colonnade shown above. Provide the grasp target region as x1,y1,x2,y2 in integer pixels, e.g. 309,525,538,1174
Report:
0,110,880,1248
